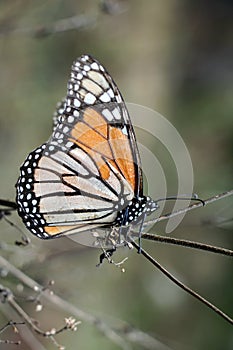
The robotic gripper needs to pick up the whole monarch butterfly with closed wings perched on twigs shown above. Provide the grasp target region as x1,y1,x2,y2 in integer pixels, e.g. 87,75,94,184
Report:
16,55,158,246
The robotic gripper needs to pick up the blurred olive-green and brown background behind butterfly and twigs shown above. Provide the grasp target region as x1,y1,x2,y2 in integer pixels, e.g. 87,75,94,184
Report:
0,0,233,350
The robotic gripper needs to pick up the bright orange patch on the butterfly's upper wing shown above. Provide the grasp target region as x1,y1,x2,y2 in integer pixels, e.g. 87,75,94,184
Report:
69,107,136,192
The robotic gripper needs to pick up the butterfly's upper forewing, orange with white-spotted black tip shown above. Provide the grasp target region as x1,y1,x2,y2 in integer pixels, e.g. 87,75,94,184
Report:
57,55,143,197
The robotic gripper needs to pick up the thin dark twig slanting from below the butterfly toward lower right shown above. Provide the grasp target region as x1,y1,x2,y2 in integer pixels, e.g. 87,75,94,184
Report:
131,239,233,324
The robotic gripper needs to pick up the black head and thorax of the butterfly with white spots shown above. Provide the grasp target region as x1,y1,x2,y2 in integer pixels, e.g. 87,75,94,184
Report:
115,196,158,226
